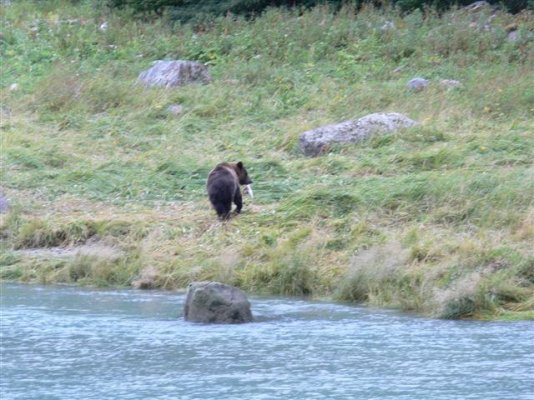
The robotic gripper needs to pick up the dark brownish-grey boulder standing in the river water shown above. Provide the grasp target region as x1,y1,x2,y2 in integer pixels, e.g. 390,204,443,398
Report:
184,282,252,324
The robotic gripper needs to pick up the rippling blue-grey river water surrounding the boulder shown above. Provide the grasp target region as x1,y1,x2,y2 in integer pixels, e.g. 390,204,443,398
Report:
0,284,534,400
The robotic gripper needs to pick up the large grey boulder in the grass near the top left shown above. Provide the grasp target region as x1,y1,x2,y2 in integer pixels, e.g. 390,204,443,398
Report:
137,60,211,88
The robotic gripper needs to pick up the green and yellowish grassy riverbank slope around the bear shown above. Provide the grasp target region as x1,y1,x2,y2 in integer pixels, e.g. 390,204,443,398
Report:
0,1,534,319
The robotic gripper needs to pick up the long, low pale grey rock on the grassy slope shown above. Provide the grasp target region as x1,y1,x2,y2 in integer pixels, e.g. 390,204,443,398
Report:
299,113,417,156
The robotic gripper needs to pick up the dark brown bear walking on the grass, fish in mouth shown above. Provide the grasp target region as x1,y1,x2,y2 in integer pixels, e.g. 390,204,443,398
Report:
207,161,252,220
